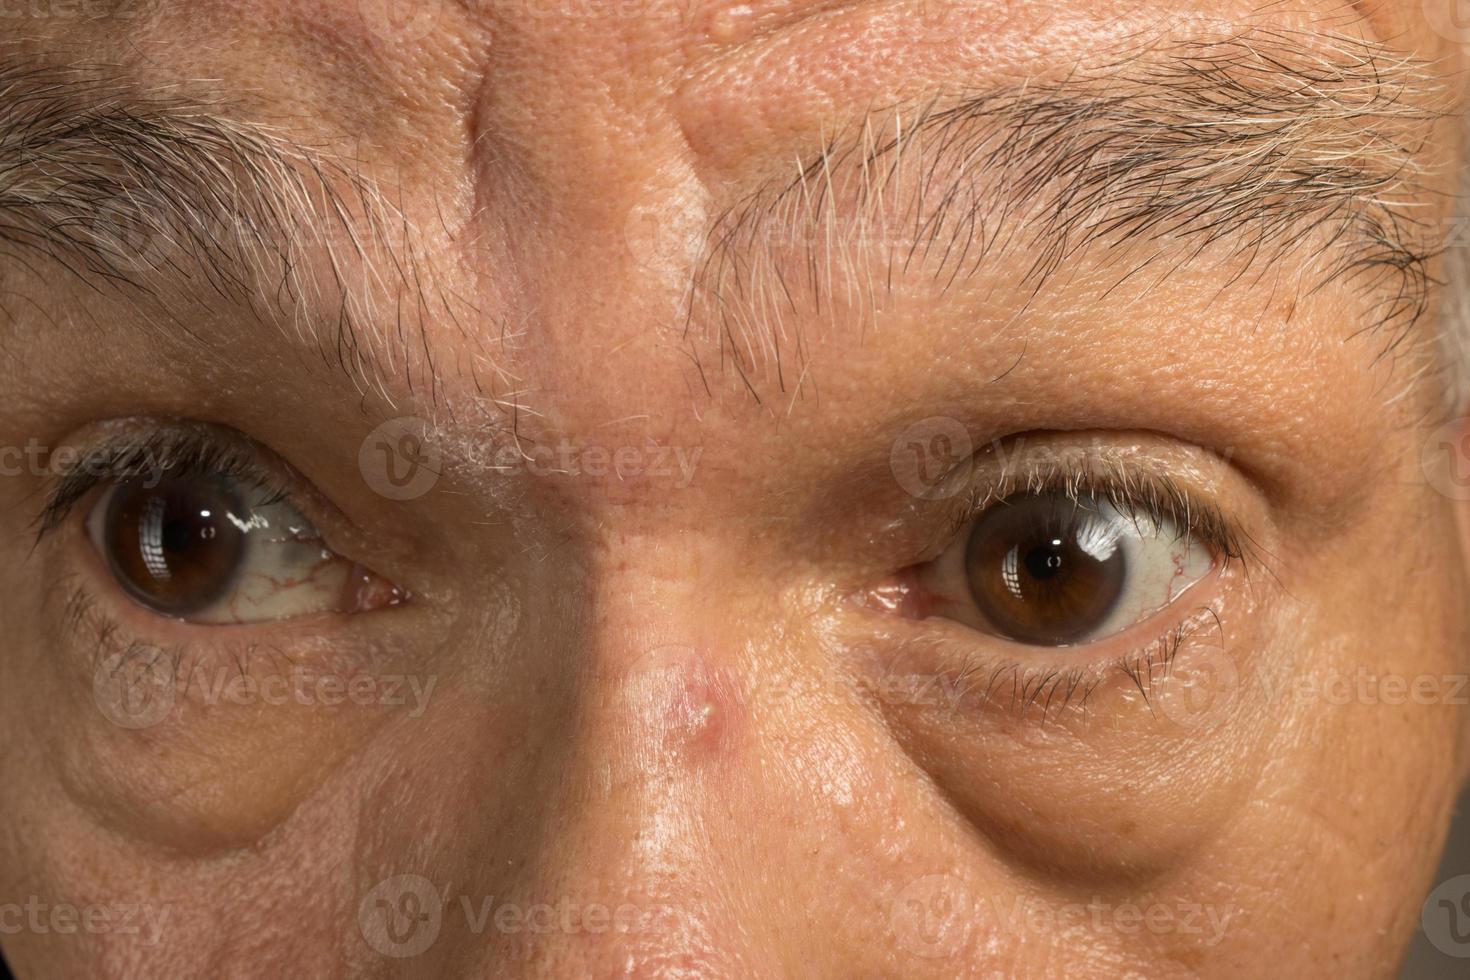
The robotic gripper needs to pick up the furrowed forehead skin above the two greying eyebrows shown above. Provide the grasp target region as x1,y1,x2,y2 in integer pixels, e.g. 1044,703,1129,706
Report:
17,0,1452,243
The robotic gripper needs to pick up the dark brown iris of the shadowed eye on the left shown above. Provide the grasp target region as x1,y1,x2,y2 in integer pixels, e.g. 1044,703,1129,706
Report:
101,478,245,616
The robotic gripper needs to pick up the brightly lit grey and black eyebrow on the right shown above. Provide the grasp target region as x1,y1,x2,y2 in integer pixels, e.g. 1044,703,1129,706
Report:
685,29,1449,401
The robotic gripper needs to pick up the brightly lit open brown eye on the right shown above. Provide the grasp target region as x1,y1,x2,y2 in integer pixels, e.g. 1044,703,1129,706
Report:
919,494,1214,646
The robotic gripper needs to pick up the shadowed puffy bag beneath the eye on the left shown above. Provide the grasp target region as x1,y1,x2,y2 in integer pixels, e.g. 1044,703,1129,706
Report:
34,587,423,858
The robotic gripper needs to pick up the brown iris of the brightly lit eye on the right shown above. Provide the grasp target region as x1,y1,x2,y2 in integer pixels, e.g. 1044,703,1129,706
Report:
964,497,1127,646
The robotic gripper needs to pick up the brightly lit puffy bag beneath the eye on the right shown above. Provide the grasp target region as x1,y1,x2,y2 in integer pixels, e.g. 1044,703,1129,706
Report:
852,610,1273,890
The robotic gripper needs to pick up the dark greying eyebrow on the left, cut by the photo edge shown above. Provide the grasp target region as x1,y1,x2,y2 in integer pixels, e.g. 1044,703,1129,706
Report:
0,62,461,404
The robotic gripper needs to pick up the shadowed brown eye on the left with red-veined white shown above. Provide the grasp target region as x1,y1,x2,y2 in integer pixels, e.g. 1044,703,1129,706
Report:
87,475,403,624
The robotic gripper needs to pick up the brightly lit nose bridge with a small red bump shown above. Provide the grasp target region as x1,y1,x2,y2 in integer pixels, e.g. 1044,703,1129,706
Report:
470,548,778,977
